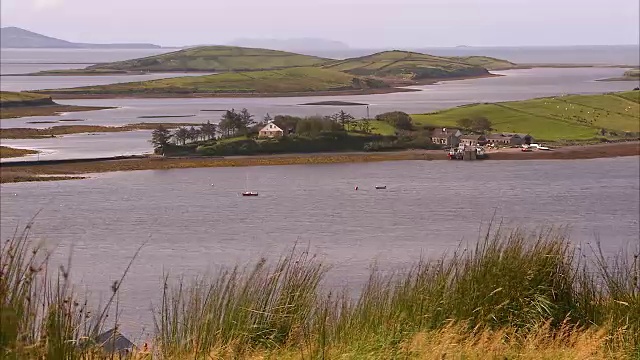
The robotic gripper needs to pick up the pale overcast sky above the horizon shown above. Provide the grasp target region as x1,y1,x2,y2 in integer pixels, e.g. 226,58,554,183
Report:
0,0,640,48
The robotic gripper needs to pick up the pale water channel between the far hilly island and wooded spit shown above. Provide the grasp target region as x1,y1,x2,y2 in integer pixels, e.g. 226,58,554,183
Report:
0,68,637,161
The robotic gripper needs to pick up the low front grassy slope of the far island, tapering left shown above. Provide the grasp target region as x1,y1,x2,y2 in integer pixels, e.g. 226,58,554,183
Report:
40,67,388,94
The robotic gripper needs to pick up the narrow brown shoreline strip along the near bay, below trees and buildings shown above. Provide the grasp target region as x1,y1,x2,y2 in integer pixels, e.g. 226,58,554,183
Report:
0,141,640,183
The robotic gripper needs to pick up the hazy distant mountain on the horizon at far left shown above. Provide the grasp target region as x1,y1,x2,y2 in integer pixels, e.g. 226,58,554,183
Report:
0,27,160,49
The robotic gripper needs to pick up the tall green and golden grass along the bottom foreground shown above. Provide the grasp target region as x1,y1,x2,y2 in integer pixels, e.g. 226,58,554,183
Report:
0,225,640,359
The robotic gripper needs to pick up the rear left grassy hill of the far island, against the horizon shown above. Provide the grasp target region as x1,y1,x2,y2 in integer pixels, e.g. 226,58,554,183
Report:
87,46,327,72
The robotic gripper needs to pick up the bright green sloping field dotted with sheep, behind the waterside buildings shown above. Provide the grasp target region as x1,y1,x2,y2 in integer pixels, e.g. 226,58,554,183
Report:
412,91,640,141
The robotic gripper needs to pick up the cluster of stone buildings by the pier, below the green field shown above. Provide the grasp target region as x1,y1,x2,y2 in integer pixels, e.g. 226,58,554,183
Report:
431,128,535,147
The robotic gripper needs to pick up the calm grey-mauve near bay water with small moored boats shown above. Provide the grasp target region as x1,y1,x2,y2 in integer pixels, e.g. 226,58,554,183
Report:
0,157,640,331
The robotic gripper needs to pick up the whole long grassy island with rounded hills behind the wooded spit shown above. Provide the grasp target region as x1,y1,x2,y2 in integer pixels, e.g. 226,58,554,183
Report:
30,46,517,98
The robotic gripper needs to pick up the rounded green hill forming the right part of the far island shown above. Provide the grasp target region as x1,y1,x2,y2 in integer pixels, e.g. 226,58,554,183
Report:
322,51,514,80
